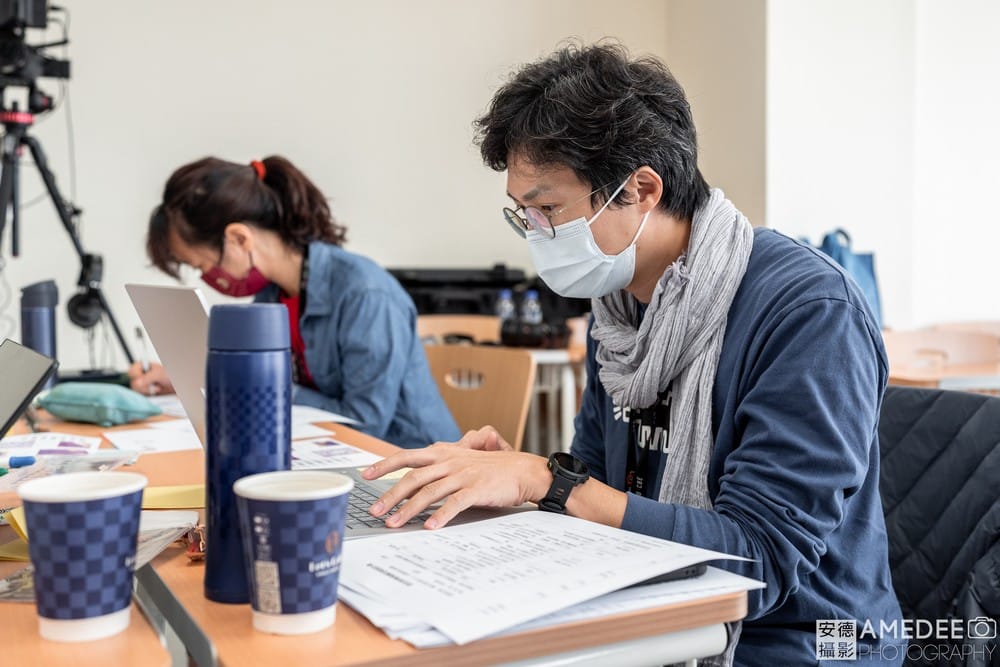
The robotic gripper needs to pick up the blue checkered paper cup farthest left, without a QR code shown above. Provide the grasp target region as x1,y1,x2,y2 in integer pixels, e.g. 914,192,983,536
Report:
18,472,146,642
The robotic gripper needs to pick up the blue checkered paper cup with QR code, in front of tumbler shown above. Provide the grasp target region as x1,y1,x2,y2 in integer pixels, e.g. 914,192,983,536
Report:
235,470,354,635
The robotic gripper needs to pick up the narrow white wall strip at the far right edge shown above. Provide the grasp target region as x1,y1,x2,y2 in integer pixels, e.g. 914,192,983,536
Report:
912,0,1000,325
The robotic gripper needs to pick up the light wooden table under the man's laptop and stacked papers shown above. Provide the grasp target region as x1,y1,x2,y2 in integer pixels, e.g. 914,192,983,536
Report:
5,414,747,667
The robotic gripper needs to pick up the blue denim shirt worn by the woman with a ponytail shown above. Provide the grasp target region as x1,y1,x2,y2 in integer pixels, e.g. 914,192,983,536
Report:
255,241,460,448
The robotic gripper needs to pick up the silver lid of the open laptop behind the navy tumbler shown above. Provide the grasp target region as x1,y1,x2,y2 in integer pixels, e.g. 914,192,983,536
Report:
125,284,208,445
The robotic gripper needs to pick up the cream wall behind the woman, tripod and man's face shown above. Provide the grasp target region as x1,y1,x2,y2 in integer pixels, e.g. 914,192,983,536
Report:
0,0,667,368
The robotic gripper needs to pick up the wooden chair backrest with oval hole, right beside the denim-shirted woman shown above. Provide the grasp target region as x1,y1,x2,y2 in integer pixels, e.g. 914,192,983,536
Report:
424,345,535,450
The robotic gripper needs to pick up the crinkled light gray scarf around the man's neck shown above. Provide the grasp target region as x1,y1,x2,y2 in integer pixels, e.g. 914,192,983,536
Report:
592,189,753,665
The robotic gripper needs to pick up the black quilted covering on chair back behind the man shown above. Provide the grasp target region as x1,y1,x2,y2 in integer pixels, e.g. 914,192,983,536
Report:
878,386,1000,667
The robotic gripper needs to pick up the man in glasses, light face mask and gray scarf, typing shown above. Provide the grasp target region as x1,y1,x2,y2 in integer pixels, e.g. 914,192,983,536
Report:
365,45,902,665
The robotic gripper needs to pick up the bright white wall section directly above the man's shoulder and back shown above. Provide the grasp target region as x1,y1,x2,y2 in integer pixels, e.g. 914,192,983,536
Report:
766,0,916,327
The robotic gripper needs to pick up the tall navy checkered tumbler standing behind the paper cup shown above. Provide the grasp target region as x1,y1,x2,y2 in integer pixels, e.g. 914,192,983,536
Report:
205,303,292,603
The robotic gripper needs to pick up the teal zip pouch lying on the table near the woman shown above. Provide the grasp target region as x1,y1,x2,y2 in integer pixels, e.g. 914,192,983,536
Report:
38,382,162,426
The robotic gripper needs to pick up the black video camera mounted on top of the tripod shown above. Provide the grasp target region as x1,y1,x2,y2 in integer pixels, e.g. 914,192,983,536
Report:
0,0,69,114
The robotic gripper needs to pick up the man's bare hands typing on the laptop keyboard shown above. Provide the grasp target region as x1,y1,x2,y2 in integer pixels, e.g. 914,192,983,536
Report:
362,434,552,528
